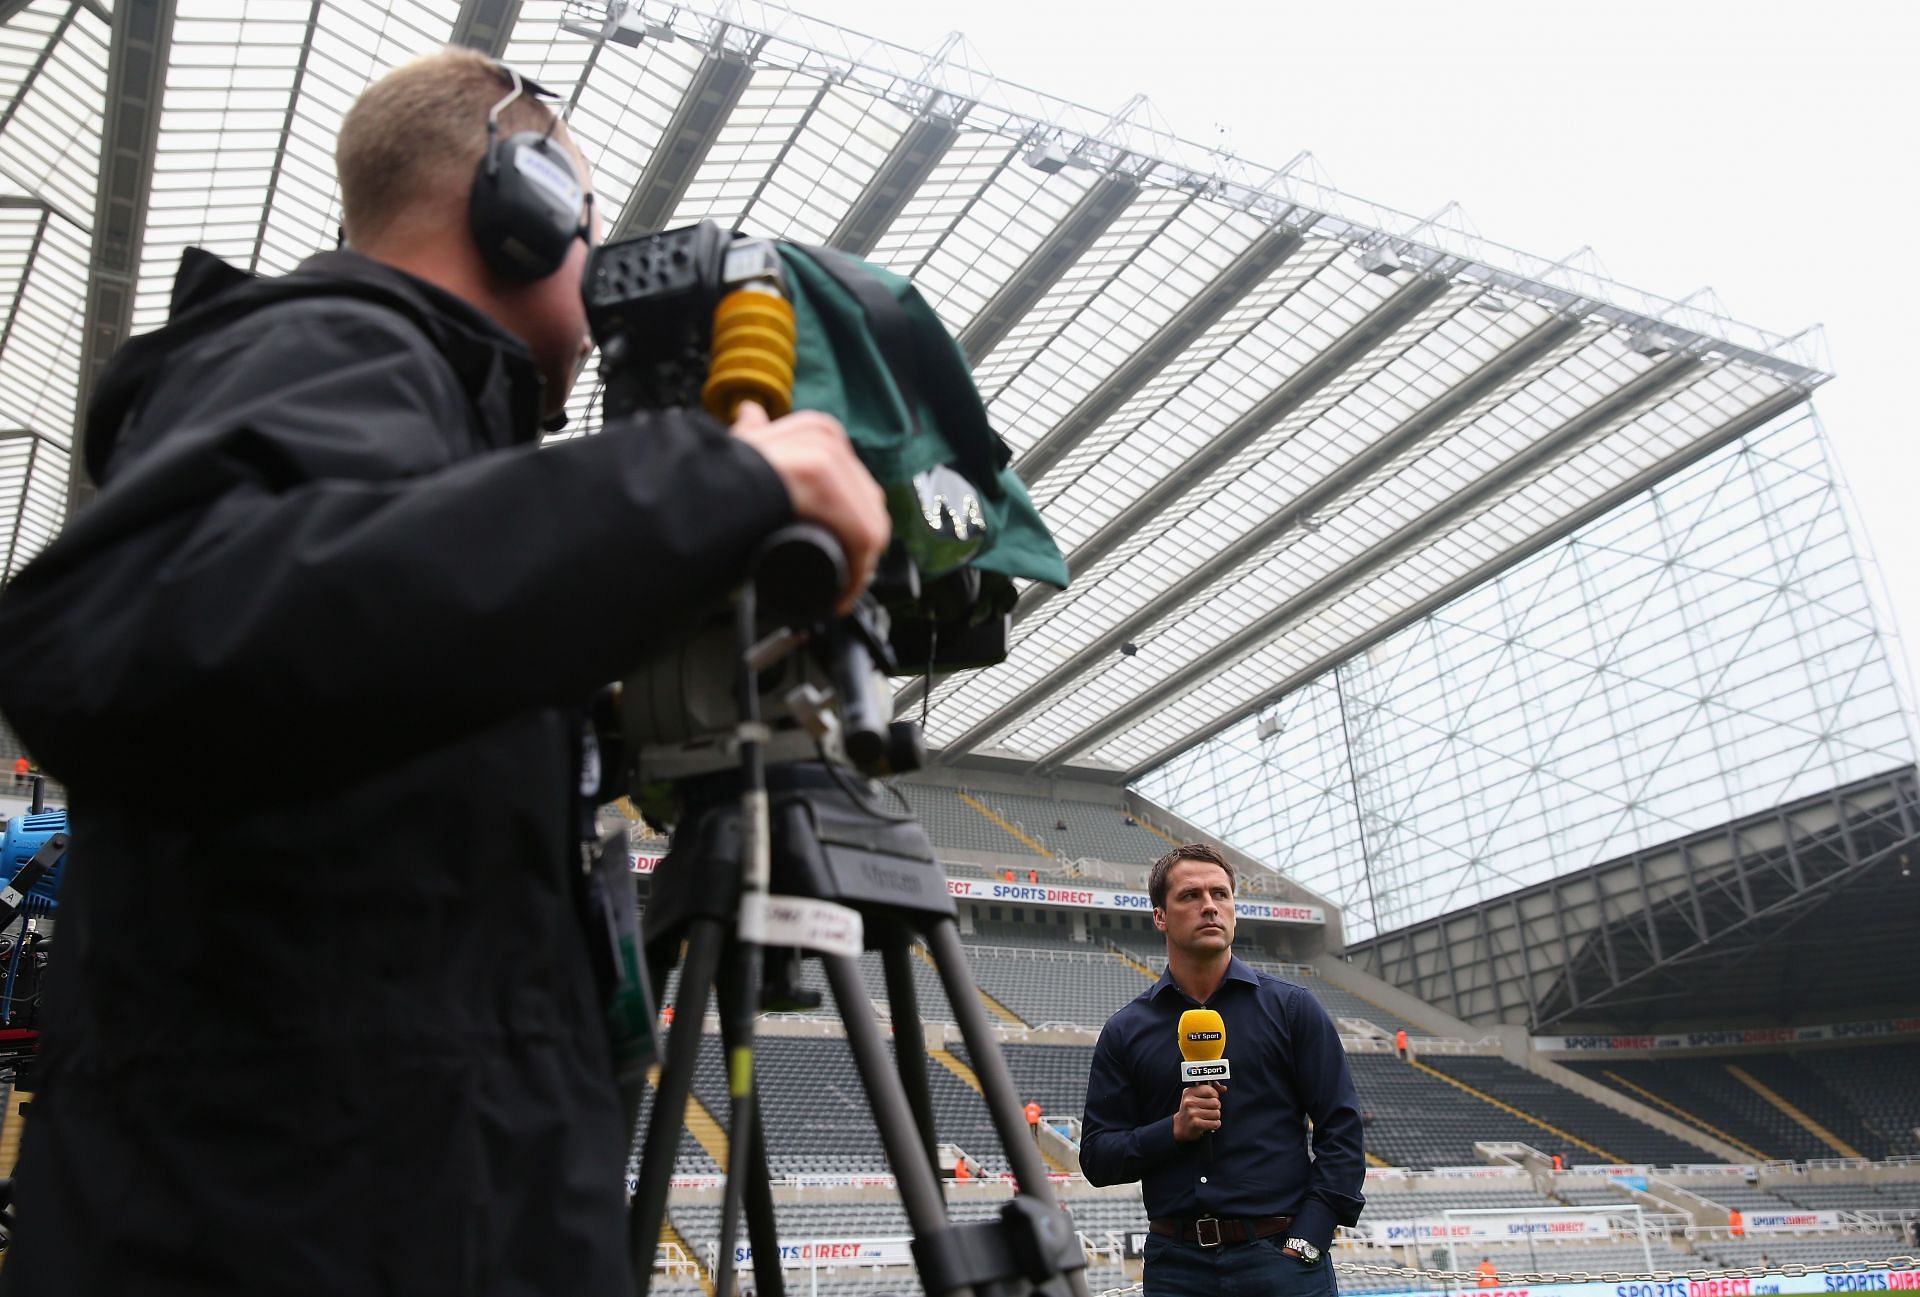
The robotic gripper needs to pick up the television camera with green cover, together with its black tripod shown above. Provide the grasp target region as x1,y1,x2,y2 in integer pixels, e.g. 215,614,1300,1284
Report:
586,223,1087,1297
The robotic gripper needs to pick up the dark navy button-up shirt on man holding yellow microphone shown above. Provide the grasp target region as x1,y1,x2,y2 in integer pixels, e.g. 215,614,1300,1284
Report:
1081,959,1367,1251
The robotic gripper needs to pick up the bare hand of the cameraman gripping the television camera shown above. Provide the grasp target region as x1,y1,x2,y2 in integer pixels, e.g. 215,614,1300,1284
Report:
733,401,893,612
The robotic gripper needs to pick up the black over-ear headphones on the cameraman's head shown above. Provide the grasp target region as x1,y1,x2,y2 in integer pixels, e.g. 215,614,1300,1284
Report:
467,63,593,284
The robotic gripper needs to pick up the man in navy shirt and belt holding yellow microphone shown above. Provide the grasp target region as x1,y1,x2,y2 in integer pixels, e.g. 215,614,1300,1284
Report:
1081,844,1367,1297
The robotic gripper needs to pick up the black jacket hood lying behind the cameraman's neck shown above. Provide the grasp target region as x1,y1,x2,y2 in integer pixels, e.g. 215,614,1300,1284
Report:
84,248,543,483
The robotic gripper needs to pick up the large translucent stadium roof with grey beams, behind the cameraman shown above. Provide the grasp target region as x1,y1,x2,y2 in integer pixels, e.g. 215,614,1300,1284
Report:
0,0,1828,777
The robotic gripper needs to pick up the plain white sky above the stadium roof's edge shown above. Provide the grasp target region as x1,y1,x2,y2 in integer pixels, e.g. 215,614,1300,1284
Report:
799,0,1920,729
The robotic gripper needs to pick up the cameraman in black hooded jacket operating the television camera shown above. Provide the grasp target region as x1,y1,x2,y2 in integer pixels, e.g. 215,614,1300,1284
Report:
0,50,887,1297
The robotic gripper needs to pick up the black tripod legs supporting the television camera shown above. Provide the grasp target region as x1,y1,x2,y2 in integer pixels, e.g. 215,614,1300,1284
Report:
628,762,1087,1297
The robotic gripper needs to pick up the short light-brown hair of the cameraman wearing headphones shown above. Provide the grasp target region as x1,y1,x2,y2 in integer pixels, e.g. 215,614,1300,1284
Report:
334,48,578,244
